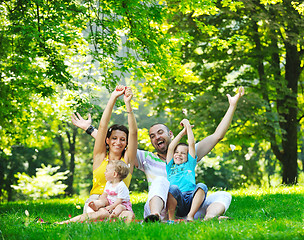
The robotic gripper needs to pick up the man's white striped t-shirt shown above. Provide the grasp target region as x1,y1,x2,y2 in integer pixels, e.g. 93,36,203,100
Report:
137,149,167,190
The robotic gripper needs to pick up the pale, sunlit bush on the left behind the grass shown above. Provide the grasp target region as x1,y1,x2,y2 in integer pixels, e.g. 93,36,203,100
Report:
12,164,69,200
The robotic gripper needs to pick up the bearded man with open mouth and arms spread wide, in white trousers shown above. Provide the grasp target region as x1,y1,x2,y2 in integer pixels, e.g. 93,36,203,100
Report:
72,87,244,221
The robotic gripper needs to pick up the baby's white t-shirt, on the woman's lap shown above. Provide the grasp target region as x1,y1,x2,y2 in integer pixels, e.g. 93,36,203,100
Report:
104,181,130,202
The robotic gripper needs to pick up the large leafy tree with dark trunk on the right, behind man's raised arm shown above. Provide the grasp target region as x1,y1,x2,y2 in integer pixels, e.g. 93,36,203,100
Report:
139,0,304,184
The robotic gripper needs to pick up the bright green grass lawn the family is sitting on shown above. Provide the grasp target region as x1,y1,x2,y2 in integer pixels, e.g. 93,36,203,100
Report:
0,186,304,240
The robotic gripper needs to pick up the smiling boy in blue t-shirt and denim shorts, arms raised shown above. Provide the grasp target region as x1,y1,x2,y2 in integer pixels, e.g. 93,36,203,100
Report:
166,119,208,221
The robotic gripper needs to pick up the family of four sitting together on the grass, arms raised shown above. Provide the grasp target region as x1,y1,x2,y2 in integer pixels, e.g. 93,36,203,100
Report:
60,86,244,223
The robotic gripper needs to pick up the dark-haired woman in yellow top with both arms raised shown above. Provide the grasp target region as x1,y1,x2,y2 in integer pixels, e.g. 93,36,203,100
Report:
59,86,137,223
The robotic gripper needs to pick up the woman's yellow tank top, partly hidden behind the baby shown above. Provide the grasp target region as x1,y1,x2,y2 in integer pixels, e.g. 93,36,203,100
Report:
90,157,132,195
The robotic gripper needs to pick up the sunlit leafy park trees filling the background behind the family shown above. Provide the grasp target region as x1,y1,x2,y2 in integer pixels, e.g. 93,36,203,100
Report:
0,0,304,205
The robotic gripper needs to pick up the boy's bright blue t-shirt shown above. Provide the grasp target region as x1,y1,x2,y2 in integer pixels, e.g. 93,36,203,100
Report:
166,153,197,192
